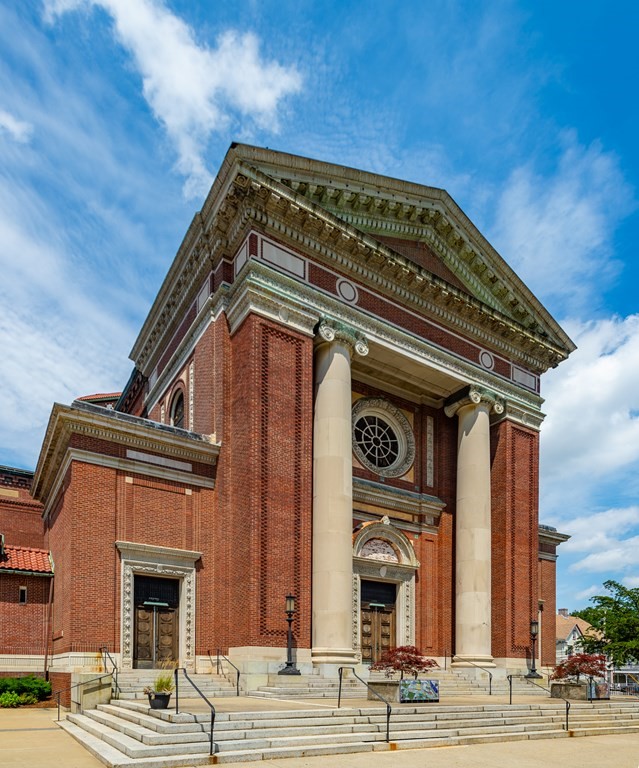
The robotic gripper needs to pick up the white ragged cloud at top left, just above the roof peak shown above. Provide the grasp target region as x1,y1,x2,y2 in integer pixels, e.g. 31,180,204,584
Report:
45,0,302,196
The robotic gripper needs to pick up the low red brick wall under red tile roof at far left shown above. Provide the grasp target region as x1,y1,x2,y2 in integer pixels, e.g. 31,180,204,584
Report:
0,573,51,654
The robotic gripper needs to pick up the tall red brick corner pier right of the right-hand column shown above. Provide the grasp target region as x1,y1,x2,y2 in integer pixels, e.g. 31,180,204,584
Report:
491,421,539,658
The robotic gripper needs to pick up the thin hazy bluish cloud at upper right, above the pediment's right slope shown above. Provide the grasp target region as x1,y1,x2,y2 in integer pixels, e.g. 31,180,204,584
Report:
493,132,636,316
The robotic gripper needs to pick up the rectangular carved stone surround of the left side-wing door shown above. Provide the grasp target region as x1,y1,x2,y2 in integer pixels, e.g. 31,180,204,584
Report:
115,541,202,671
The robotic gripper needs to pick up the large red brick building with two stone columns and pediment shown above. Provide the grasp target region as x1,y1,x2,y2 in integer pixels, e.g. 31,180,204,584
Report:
0,144,574,687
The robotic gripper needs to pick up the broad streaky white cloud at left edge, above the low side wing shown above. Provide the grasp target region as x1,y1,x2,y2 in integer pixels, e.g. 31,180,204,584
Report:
0,178,132,466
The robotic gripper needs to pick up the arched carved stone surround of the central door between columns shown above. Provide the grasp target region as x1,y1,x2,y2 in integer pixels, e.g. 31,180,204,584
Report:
353,516,419,651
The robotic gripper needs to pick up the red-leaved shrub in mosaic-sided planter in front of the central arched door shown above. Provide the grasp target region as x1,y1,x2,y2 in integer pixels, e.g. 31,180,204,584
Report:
369,645,439,702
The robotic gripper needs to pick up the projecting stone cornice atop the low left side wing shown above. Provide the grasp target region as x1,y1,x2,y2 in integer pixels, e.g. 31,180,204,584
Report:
32,401,220,506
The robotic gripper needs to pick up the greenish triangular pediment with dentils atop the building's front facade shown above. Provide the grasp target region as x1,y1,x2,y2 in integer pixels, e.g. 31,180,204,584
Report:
227,144,575,355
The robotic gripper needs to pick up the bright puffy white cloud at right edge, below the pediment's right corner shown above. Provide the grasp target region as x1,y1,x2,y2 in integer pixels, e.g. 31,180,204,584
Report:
541,315,639,511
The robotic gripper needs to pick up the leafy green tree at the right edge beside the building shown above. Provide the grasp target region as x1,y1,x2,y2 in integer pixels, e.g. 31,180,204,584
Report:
572,580,639,666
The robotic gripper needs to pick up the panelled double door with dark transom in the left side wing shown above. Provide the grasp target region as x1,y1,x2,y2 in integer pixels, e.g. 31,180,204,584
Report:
133,576,180,669
